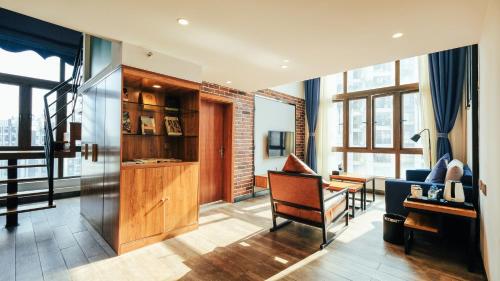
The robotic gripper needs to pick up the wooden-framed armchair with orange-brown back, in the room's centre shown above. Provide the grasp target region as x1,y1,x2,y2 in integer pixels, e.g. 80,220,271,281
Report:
268,171,349,249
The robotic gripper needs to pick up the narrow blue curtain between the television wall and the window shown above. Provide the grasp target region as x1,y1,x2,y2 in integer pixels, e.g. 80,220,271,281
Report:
305,78,320,172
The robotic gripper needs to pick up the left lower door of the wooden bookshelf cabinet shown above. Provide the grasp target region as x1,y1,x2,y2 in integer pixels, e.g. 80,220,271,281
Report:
120,168,165,244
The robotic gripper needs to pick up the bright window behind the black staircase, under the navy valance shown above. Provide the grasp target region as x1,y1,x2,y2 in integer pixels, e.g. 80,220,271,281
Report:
0,49,81,178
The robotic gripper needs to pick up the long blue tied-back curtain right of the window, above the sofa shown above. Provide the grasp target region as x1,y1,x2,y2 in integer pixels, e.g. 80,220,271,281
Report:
429,47,466,159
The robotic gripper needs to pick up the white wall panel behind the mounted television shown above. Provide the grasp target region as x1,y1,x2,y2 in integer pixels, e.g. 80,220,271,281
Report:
254,96,295,175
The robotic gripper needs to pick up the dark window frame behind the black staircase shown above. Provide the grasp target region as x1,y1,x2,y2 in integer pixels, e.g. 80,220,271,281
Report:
0,59,79,179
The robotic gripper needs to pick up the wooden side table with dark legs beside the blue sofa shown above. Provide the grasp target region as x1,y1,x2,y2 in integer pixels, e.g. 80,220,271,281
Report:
403,200,477,271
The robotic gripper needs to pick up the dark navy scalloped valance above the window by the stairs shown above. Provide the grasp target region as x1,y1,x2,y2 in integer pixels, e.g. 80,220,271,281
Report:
0,8,81,64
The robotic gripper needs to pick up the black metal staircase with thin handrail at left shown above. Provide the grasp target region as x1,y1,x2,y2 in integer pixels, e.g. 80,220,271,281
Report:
0,37,83,227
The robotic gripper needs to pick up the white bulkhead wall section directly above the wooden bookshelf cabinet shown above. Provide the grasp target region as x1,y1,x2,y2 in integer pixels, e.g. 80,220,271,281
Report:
122,42,202,82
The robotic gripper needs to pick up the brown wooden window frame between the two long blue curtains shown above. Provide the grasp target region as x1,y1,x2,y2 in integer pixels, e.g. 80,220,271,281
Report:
332,60,423,178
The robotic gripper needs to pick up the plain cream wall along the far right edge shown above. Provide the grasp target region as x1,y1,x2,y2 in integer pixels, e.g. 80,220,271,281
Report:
479,0,500,281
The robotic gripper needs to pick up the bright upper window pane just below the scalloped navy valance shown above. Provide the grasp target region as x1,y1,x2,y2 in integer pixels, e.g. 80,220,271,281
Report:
0,48,60,81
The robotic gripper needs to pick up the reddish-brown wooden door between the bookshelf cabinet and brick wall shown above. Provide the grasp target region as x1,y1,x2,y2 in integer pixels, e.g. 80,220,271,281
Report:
200,100,224,204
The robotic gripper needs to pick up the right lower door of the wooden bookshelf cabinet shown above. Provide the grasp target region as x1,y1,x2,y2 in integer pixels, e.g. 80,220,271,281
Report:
163,164,199,232
